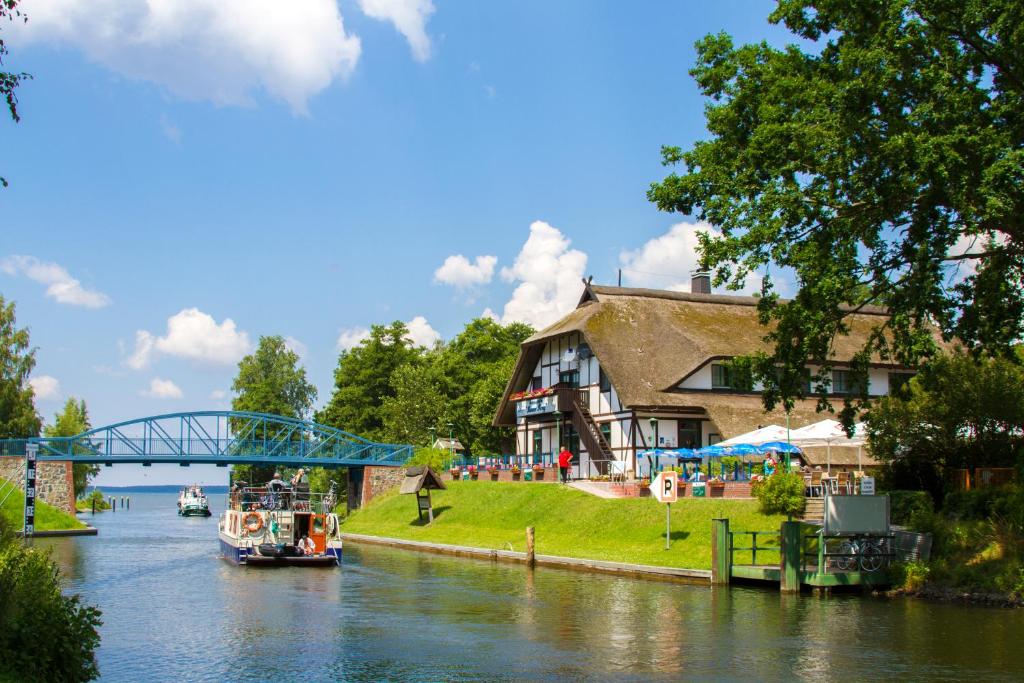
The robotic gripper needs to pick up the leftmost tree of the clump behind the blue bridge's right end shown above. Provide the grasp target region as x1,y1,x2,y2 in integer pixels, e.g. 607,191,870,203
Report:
316,321,423,440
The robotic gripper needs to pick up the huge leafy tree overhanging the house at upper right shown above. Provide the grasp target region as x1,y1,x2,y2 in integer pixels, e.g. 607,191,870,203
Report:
648,0,1024,424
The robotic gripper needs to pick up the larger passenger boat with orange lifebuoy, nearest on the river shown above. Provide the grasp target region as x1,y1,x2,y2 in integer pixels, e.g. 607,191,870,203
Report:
218,485,342,567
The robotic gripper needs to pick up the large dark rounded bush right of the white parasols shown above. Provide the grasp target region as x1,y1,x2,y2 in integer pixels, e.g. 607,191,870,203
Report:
866,352,1024,496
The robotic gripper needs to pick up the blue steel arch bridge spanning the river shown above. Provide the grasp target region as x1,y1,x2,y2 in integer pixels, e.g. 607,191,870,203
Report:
0,411,413,469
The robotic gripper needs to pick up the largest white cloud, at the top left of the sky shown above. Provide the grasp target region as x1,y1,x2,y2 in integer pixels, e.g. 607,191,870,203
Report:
9,0,362,113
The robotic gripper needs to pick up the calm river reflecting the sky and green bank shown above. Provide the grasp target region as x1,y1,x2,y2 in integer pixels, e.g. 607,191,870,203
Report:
36,494,1024,682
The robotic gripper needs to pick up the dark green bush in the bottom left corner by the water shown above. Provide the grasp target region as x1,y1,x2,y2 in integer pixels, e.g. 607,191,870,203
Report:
0,519,101,681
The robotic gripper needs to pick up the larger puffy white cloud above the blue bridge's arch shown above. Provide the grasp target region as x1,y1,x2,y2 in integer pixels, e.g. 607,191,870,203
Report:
125,308,252,370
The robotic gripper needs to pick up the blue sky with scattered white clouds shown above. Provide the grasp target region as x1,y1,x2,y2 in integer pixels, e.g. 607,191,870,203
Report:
0,0,788,485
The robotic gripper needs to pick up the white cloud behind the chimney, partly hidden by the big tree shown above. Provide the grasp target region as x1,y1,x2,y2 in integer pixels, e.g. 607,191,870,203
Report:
618,221,761,294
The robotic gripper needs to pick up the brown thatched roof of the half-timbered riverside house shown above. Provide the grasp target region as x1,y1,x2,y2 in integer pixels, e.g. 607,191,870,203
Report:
495,285,913,437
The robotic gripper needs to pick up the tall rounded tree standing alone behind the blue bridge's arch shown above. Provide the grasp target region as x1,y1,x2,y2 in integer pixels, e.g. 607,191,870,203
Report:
231,336,316,483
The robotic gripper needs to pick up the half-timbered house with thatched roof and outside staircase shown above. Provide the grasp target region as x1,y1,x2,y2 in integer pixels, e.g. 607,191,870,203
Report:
494,284,910,479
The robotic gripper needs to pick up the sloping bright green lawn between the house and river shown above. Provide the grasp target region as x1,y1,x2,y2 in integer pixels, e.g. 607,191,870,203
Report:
342,481,784,569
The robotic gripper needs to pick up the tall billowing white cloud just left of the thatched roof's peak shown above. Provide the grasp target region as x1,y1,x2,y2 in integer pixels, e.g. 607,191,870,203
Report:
502,220,587,329
